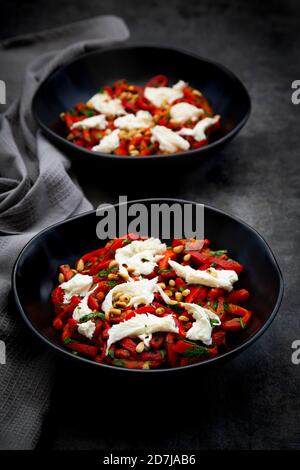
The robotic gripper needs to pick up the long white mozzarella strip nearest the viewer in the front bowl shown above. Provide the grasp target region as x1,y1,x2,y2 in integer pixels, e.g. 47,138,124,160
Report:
106,313,179,355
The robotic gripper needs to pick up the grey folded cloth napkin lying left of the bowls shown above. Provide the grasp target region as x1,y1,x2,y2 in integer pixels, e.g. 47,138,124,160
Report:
0,16,129,449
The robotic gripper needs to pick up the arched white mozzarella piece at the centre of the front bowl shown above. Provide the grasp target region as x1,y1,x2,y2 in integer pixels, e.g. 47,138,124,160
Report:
102,277,158,313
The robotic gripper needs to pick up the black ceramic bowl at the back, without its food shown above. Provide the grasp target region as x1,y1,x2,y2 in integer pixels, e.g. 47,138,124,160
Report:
33,46,250,161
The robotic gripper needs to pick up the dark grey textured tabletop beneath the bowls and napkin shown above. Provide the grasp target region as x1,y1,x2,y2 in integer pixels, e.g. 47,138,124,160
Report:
0,0,300,450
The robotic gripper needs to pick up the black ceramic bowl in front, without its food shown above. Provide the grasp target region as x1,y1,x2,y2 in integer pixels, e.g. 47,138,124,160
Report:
12,199,283,373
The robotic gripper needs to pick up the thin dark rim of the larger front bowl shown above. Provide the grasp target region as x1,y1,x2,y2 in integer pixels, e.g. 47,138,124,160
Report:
11,198,284,374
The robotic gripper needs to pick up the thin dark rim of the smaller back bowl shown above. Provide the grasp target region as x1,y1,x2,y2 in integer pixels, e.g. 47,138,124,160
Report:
32,43,252,161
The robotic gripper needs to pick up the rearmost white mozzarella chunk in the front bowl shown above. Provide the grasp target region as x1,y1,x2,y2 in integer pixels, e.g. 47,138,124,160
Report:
115,238,167,276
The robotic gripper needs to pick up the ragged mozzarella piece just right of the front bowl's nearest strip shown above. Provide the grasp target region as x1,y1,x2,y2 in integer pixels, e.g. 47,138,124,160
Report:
180,302,221,346
